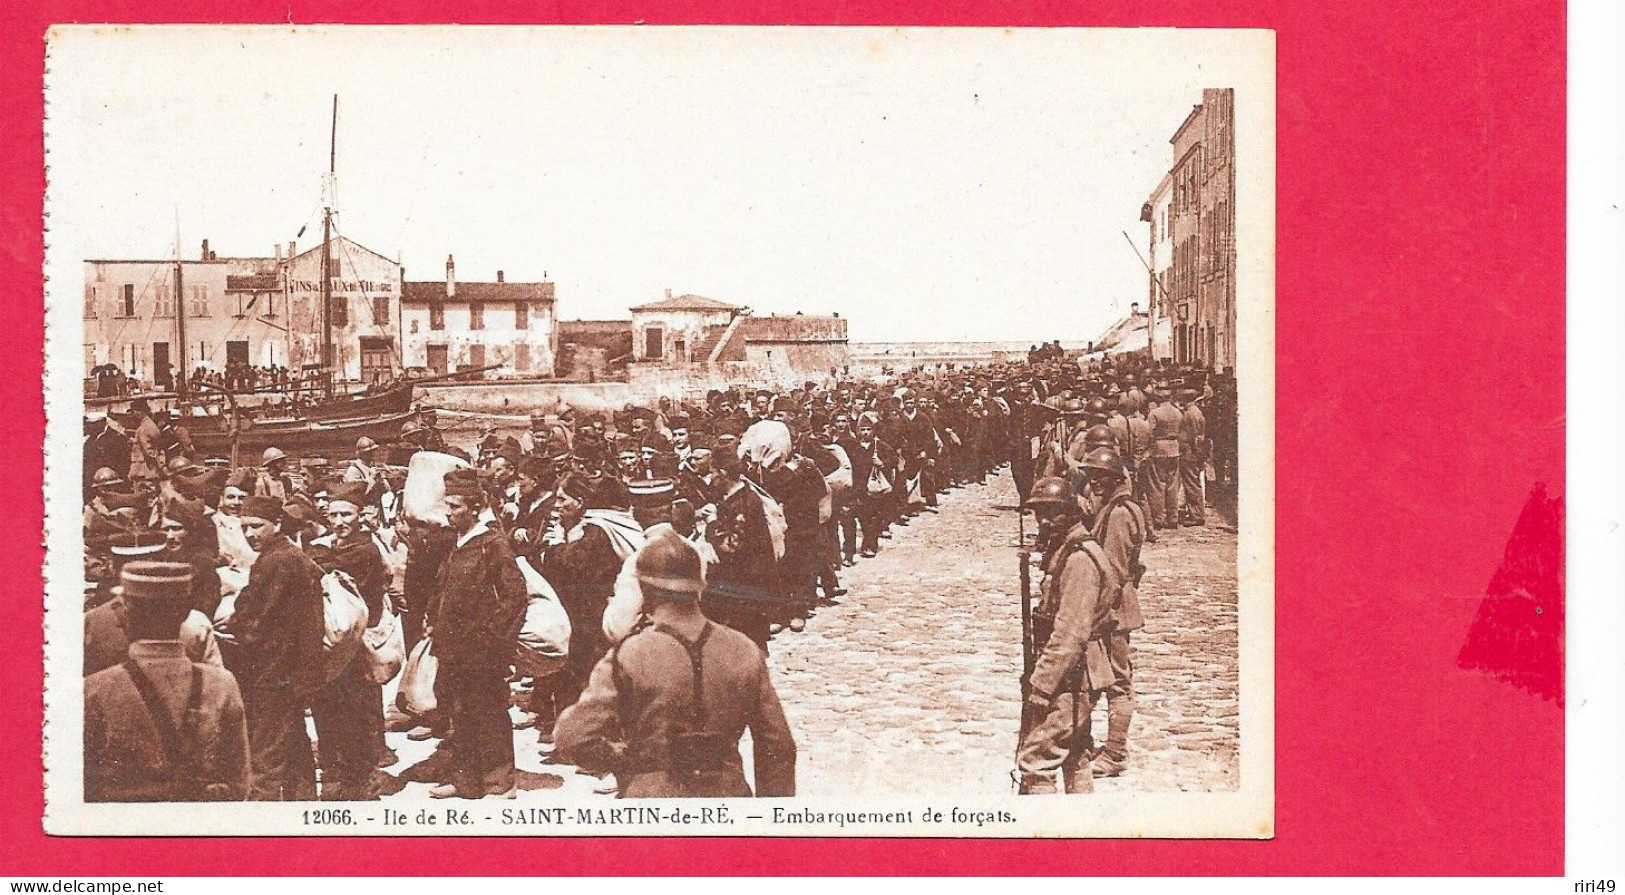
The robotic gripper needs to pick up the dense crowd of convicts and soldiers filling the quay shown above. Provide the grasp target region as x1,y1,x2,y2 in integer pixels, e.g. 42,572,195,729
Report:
85,352,1235,801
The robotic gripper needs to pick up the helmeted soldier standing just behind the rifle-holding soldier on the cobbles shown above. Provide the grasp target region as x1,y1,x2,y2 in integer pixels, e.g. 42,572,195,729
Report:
1079,448,1151,776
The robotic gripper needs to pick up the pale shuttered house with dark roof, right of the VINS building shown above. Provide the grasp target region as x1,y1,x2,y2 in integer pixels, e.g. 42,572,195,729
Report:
400,255,559,378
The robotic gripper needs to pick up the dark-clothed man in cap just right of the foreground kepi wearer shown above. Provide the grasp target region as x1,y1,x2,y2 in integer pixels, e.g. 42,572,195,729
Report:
226,495,325,801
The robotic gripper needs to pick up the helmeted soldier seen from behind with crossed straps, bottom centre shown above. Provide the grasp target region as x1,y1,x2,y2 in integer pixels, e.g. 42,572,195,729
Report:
554,531,796,798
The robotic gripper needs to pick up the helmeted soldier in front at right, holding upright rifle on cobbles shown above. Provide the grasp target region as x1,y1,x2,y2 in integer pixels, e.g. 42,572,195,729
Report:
1016,478,1112,794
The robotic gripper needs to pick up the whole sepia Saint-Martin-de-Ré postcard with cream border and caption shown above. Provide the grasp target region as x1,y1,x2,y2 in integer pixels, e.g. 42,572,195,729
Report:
44,26,1276,838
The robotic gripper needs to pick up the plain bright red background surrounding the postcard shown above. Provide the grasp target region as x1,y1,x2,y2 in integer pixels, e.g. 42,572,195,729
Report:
0,0,1565,876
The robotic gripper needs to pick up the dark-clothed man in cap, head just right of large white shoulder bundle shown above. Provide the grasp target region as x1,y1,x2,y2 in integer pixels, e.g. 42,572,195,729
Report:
429,469,527,799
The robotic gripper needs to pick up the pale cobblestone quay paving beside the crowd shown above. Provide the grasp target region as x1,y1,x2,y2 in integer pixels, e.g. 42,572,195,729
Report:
388,473,1240,802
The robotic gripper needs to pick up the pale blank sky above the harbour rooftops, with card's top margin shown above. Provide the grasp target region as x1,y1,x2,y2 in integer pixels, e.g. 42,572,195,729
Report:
47,28,1274,341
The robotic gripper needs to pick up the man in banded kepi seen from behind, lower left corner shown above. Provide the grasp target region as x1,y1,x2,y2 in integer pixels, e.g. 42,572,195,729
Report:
83,560,249,802
